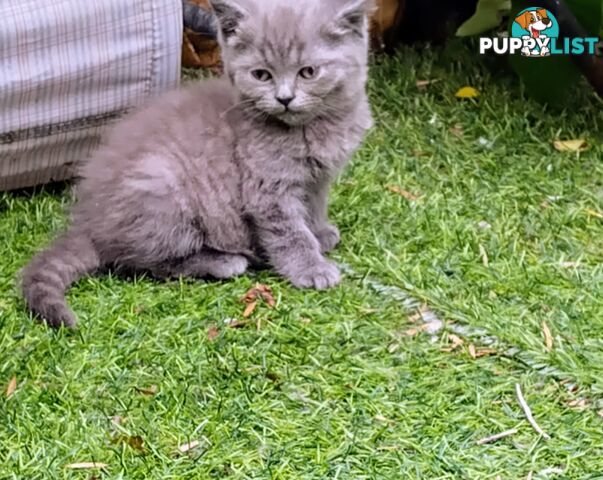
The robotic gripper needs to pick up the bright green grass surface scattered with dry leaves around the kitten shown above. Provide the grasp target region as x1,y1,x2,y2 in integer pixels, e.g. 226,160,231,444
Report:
0,40,603,480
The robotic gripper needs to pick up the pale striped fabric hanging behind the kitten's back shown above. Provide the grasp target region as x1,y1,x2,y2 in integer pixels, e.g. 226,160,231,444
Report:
0,0,182,190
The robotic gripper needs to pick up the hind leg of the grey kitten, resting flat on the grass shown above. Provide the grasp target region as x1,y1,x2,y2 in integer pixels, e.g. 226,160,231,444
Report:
151,250,249,279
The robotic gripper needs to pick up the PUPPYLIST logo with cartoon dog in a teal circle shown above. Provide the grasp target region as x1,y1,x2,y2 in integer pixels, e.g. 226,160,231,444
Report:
479,7,599,57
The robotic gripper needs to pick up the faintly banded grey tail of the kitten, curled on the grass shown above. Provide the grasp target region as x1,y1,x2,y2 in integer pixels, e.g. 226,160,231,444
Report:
22,230,101,328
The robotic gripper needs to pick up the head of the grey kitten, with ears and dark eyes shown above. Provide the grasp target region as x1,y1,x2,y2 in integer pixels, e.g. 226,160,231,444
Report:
211,0,372,125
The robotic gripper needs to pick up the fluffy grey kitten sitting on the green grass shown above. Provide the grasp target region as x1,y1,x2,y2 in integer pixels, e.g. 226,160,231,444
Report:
23,0,371,327
